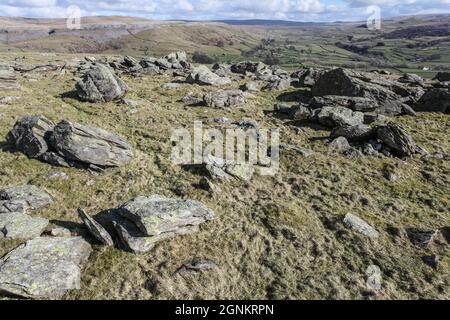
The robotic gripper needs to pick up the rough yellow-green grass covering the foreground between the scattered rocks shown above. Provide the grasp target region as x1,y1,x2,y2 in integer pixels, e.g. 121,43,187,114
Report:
0,54,450,299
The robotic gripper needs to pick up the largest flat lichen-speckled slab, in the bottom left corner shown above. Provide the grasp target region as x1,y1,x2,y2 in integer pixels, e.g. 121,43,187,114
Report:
0,237,92,298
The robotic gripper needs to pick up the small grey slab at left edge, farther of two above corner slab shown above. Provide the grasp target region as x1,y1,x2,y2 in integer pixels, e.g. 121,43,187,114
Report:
0,185,53,214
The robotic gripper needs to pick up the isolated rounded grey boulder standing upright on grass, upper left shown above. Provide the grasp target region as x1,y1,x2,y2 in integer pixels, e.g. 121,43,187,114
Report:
76,64,128,102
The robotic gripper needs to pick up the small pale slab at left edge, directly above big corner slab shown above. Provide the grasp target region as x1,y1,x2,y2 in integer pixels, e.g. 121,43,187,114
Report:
0,212,49,239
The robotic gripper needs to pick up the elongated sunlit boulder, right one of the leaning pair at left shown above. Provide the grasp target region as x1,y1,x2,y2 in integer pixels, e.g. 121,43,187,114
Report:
52,121,133,167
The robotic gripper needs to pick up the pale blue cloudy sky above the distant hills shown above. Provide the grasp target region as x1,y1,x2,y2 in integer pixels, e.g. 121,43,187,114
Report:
0,0,450,21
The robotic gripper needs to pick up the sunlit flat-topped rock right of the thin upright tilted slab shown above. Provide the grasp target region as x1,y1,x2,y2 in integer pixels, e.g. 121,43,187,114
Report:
118,195,214,236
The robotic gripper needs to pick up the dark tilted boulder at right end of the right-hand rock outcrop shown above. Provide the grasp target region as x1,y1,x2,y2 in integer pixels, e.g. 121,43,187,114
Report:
377,123,418,157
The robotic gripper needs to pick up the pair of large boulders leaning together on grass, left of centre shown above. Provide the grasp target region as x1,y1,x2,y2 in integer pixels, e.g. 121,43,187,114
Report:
7,115,133,169
